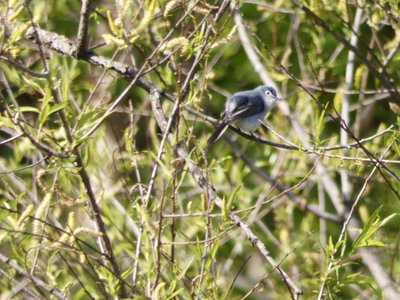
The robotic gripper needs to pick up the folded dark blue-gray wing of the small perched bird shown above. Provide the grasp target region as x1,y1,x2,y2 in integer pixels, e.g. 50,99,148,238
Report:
225,94,264,122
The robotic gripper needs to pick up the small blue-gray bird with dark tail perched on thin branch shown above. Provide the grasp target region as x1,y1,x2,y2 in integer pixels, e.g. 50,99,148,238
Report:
207,85,280,146
